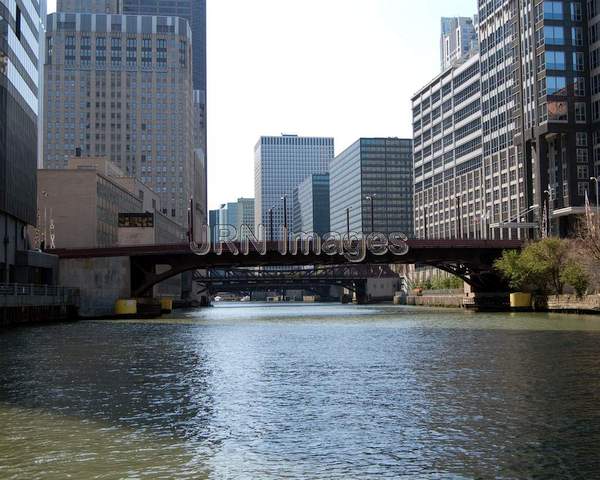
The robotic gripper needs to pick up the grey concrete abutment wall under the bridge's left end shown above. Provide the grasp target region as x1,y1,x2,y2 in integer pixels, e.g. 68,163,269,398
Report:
59,257,131,317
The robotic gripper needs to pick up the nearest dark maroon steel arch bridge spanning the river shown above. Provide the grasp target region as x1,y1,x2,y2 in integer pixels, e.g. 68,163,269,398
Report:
49,239,523,316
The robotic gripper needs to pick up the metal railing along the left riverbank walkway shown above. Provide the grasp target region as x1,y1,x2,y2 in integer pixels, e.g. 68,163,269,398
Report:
0,283,79,307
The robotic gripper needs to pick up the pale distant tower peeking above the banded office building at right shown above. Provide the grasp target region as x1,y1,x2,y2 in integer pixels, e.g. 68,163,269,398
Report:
440,15,479,71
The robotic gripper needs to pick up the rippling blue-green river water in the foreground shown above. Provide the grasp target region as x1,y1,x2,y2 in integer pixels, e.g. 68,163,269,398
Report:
0,304,600,479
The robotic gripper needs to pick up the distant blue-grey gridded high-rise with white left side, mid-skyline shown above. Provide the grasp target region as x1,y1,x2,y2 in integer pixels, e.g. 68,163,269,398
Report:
254,135,334,240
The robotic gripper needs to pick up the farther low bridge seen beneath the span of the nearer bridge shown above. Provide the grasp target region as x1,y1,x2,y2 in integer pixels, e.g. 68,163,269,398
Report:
194,264,400,303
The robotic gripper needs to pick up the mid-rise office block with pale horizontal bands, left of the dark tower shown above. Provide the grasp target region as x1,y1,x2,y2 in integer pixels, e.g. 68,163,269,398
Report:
412,55,527,238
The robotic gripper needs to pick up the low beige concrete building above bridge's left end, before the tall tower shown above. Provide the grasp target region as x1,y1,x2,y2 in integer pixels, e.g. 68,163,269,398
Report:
33,158,185,248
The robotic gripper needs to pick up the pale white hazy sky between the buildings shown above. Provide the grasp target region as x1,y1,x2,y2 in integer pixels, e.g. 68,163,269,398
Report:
49,0,477,208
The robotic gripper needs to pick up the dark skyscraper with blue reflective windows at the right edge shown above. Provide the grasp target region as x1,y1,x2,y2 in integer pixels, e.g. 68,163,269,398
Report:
479,0,600,235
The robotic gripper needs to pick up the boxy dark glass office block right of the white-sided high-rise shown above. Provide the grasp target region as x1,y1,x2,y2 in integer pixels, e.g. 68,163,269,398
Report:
329,138,413,237
